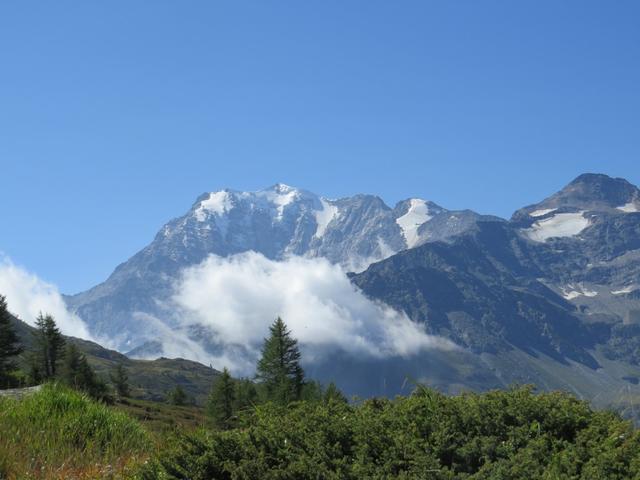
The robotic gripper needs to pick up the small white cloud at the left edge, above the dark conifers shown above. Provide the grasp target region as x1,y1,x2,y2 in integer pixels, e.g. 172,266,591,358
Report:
0,257,92,340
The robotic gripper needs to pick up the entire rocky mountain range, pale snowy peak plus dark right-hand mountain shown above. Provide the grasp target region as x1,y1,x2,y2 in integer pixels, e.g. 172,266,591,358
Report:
68,174,640,403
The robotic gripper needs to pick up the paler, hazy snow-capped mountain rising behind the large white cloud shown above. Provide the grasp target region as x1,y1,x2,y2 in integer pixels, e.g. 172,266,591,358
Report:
66,184,490,356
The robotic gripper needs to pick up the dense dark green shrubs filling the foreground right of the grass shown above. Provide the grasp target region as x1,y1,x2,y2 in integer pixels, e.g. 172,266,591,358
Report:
141,387,640,480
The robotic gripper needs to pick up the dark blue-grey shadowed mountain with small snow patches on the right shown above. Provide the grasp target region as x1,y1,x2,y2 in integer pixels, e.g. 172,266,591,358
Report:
352,174,640,404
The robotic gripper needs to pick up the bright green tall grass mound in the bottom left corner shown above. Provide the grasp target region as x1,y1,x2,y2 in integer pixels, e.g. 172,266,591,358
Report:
0,384,153,480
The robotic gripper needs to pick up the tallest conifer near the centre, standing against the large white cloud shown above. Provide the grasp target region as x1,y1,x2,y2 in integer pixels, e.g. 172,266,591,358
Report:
256,317,304,404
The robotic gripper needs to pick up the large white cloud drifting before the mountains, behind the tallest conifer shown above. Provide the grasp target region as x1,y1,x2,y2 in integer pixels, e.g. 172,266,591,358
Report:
173,252,455,373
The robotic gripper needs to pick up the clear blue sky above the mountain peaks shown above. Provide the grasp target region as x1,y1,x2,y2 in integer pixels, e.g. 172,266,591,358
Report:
0,0,640,293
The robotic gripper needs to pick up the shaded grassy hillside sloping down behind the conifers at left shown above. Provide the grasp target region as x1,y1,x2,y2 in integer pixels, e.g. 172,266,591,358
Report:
9,319,219,405
